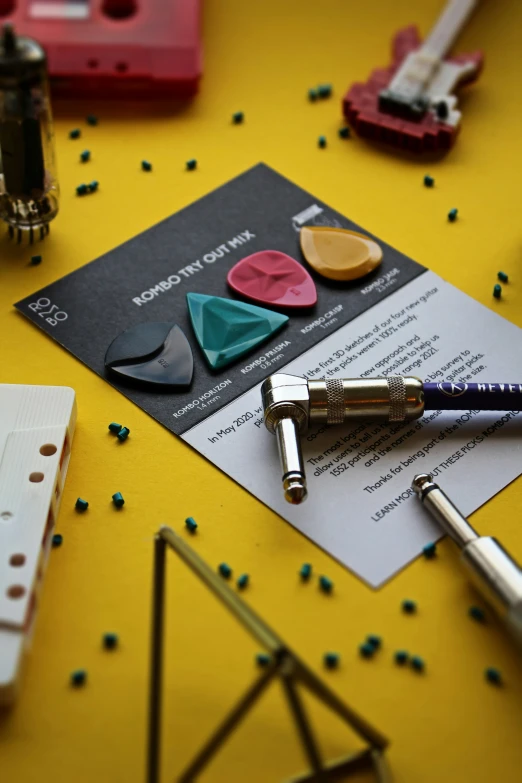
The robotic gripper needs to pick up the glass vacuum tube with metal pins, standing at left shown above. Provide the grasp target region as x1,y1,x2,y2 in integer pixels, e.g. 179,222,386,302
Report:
0,25,59,242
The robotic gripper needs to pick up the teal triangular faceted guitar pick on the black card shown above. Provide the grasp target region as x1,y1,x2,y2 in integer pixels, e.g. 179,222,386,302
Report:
187,294,288,370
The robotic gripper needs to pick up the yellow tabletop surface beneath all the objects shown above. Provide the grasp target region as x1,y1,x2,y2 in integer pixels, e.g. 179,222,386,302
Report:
0,0,522,783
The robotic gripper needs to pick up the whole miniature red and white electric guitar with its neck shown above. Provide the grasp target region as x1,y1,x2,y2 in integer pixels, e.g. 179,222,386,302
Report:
343,0,484,152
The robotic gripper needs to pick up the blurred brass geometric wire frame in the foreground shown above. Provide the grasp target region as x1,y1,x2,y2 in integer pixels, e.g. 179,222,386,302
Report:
147,527,391,783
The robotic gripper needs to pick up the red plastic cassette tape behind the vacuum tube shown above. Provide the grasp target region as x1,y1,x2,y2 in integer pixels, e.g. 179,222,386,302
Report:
0,0,201,98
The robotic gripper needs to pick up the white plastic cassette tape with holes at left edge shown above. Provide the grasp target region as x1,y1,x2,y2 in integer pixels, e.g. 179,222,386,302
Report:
0,385,76,704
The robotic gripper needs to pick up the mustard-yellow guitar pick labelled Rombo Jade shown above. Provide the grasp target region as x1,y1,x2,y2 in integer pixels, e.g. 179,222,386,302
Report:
300,226,382,280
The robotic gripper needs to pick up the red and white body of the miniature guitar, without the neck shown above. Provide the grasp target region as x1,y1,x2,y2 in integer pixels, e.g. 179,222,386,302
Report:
343,25,484,152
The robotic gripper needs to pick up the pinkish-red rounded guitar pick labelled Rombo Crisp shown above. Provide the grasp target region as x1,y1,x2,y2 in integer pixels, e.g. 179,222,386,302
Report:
227,250,317,307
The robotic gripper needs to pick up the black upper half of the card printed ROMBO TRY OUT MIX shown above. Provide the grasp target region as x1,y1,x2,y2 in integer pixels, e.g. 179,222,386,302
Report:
16,164,425,435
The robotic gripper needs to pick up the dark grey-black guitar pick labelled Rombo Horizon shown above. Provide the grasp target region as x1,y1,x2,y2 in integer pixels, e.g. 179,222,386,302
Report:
105,321,194,386
